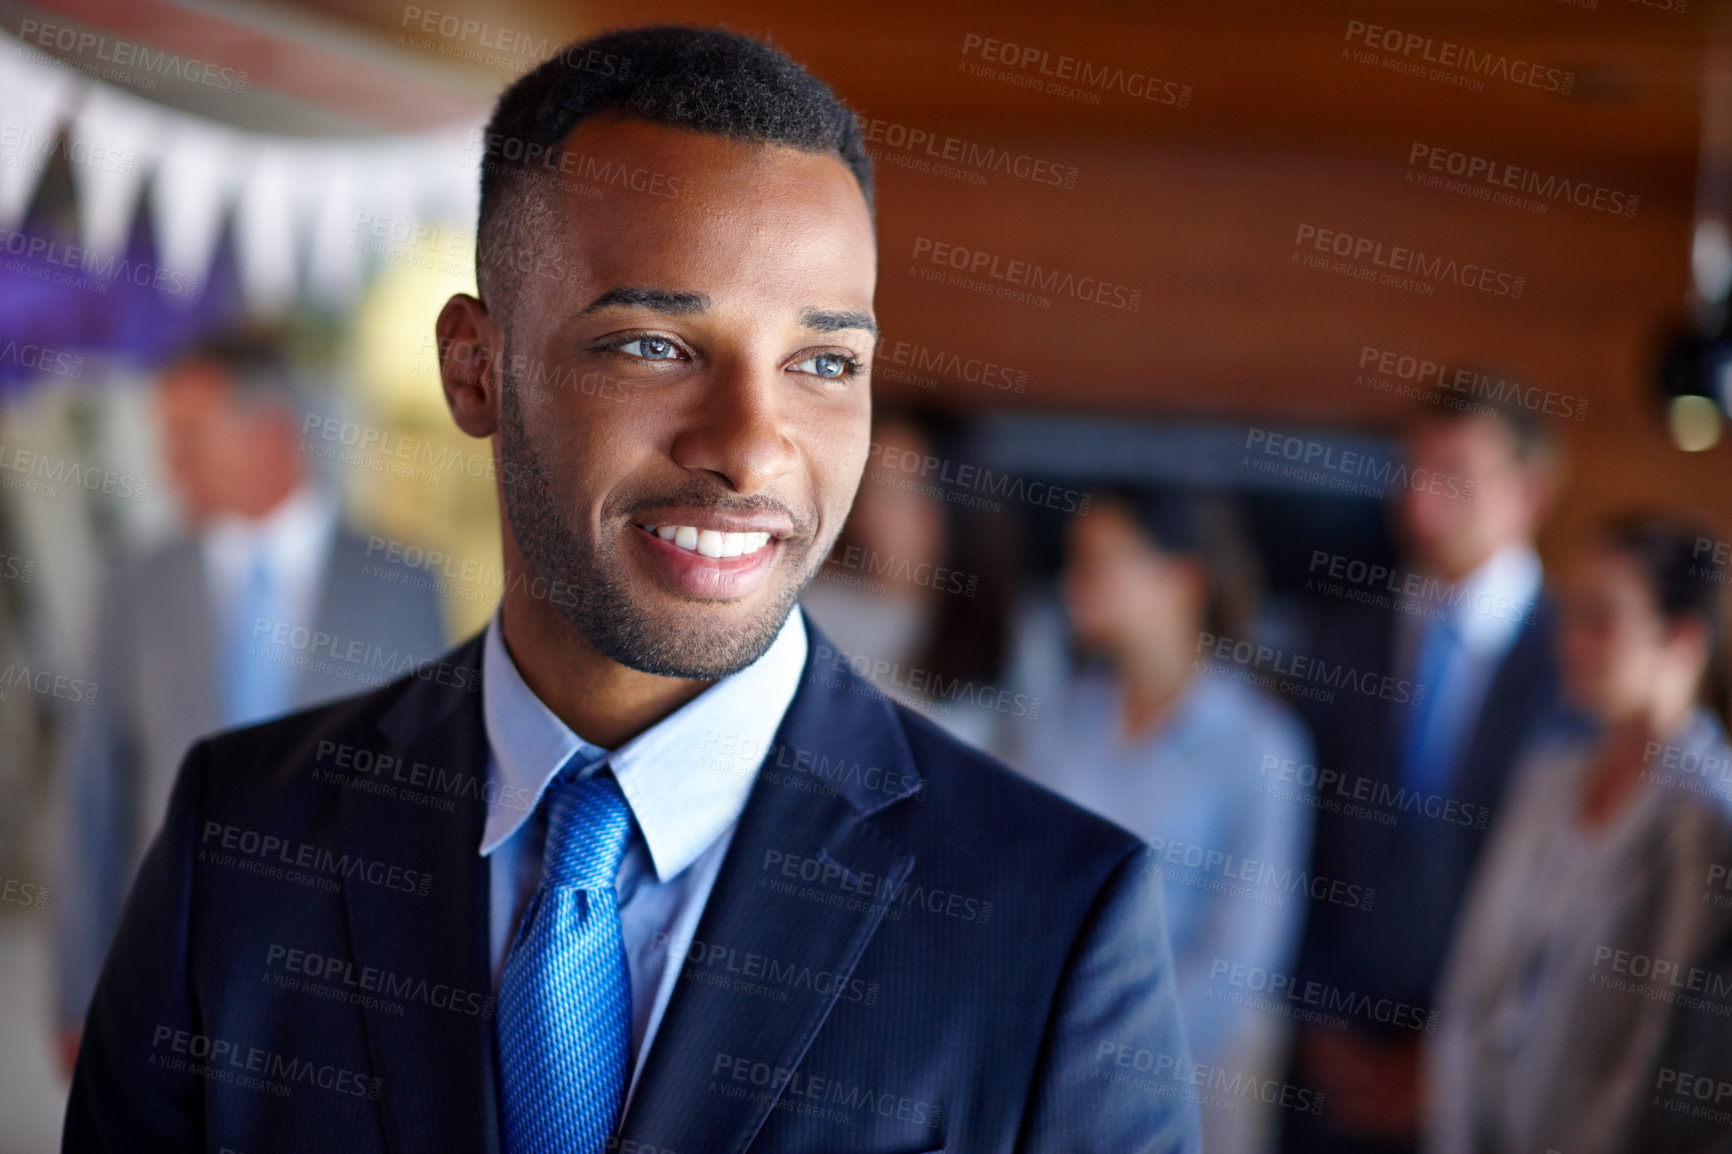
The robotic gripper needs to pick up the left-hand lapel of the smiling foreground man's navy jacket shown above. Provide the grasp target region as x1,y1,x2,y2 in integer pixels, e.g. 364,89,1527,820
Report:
341,638,499,1154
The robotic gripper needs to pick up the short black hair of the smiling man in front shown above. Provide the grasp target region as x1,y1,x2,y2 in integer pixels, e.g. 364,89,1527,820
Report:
475,24,873,310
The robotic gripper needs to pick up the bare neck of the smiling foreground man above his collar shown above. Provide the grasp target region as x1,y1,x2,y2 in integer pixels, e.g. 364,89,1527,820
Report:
501,582,714,749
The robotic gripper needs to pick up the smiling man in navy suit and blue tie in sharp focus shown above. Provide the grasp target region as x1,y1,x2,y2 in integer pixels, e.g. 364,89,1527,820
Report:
64,28,1198,1154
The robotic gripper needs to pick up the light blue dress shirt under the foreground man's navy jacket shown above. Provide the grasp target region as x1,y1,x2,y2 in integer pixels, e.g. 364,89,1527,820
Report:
480,610,807,1107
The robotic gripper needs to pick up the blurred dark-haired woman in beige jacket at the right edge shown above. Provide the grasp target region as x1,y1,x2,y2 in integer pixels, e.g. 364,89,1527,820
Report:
1427,516,1732,1154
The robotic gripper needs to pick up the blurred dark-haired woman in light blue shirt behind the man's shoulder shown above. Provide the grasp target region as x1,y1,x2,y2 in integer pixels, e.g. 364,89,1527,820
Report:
1011,489,1313,1152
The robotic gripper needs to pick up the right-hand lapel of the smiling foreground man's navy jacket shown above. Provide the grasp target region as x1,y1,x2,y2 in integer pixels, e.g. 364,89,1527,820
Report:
620,622,921,1152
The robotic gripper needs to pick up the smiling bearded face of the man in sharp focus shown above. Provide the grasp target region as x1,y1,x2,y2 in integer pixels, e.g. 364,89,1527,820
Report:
467,118,876,677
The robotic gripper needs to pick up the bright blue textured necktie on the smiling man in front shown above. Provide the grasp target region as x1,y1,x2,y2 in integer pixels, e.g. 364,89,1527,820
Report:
497,768,632,1154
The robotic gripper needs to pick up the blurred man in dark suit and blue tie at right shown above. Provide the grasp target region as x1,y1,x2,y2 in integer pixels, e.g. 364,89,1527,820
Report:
1285,404,1557,1154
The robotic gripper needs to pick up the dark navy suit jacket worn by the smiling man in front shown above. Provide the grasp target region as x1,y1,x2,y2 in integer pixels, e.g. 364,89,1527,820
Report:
64,624,1205,1154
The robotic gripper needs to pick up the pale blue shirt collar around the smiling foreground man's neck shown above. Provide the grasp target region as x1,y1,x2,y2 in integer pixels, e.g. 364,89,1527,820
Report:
481,610,807,882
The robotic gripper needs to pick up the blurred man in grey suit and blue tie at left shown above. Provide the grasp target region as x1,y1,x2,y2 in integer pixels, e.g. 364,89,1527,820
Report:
55,334,445,1071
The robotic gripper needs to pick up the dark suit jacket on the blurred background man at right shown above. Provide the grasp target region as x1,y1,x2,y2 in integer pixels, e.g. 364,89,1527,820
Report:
1299,600,1557,1034
